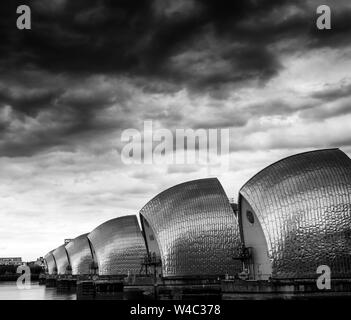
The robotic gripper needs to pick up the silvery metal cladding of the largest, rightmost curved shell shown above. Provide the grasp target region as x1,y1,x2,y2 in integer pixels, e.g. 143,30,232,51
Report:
240,149,351,278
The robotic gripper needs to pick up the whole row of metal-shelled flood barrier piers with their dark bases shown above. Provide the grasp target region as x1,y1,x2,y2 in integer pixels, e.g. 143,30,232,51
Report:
41,149,351,299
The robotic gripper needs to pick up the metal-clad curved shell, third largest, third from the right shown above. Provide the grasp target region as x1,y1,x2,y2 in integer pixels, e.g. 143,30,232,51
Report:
88,216,146,275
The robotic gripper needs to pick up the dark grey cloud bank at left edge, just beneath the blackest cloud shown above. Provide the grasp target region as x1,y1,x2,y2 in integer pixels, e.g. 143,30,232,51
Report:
0,72,135,157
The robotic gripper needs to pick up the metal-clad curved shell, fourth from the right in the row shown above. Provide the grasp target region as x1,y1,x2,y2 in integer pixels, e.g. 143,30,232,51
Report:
66,233,93,275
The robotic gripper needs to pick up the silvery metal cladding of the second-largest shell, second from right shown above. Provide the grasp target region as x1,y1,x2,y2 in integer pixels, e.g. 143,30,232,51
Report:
140,178,241,277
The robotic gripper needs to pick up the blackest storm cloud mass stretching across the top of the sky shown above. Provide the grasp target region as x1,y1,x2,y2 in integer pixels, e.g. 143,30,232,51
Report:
0,0,312,88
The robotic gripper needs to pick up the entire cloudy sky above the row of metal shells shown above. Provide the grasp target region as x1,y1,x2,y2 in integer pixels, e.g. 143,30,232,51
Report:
0,0,351,260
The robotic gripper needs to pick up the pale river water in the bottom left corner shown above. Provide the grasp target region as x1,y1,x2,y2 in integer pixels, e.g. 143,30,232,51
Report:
0,281,76,300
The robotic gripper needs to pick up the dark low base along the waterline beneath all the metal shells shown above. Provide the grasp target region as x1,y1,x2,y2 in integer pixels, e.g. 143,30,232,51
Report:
54,276,351,301
